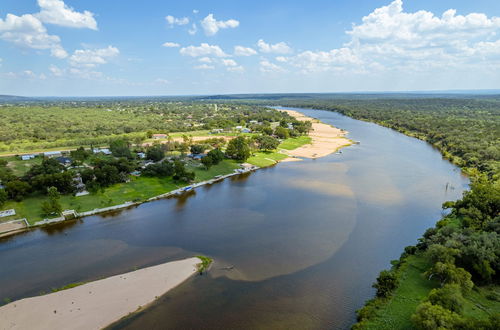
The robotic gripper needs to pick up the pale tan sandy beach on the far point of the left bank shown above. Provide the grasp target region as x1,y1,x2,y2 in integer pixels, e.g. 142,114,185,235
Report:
280,110,352,158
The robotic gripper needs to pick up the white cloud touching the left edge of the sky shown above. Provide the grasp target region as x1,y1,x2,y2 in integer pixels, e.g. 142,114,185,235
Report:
0,14,68,58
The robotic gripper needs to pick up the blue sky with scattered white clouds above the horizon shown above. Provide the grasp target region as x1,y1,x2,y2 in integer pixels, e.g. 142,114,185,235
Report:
0,0,500,96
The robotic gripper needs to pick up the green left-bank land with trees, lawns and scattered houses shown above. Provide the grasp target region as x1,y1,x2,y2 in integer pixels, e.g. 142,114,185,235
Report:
0,102,311,224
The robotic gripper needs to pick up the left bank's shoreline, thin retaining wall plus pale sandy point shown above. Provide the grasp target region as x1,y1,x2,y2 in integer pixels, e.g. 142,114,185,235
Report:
0,109,354,238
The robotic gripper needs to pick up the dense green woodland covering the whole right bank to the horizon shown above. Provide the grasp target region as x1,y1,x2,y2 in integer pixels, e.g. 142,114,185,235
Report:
213,95,500,330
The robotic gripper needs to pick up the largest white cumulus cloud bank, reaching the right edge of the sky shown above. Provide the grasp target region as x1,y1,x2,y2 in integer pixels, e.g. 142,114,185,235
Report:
284,0,500,72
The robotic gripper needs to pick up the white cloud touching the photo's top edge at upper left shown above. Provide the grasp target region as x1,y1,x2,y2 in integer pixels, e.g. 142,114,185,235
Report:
36,0,97,30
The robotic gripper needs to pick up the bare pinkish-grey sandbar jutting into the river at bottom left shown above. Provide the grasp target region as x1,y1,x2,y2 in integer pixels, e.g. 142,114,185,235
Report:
0,258,201,330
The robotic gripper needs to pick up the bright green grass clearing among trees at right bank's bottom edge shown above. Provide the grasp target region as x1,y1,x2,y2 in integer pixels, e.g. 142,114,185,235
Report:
363,256,439,329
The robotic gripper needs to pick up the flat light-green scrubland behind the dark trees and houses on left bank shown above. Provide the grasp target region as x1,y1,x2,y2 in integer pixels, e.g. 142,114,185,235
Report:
0,101,289,152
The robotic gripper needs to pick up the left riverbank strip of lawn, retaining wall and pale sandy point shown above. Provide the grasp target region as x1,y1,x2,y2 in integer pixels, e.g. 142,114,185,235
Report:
0,110,352,237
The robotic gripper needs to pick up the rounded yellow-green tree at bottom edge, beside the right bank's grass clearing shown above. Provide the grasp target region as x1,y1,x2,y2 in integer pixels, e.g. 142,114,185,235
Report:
411,302,464,330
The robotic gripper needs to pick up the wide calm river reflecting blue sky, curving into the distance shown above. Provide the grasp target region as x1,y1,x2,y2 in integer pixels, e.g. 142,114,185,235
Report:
0,109,468,329
